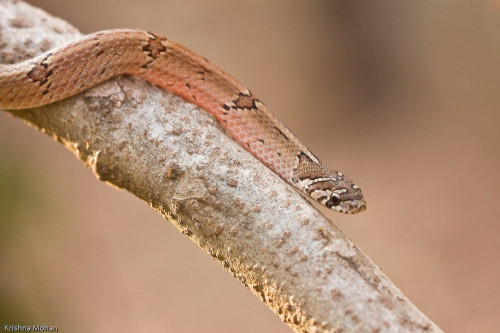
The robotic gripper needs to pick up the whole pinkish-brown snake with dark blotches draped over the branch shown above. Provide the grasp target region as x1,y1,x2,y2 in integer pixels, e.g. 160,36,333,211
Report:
0,29,366,214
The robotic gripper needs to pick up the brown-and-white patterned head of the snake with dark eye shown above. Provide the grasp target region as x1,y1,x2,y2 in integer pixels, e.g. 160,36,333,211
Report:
293,153,366,214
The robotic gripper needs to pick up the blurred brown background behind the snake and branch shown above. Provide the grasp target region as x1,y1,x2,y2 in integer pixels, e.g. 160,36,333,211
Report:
0,0,500,332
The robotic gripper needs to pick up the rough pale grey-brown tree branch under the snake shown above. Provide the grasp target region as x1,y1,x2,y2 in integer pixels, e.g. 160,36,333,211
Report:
0,0,441,332
